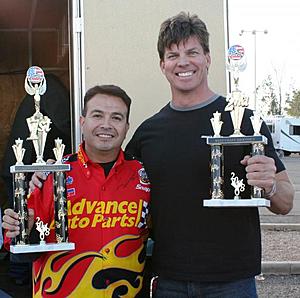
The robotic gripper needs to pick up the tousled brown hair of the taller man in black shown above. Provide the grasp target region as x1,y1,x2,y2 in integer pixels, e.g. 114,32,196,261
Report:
157,12,209,61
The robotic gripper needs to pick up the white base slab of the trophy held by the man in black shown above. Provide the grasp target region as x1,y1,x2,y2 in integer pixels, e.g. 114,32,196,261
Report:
203,198,271,207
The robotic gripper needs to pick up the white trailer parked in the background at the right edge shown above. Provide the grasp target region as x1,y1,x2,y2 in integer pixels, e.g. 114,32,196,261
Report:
264,116,300,156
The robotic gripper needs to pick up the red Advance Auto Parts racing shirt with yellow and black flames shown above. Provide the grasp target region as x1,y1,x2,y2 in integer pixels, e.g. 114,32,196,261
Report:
28,145,150,297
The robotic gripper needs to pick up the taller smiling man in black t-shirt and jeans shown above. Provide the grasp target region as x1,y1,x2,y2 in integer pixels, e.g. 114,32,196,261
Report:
126,13,294,298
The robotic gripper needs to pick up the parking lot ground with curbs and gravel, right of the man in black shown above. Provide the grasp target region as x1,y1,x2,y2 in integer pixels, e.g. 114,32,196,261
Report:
256,154,300,298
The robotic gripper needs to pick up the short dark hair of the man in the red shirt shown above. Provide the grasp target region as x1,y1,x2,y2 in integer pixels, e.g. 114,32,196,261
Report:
82,85,131,123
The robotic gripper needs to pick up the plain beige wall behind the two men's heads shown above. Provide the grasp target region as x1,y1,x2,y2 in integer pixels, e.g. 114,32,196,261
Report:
83,0,226,143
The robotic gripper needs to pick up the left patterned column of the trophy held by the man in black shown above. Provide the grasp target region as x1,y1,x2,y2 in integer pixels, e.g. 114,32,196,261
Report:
211,145,224,199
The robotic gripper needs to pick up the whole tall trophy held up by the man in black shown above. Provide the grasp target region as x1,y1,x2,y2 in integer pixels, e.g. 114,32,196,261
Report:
203,45,270,207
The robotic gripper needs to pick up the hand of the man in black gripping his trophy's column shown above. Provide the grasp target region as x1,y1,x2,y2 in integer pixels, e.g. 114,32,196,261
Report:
241,155,276,193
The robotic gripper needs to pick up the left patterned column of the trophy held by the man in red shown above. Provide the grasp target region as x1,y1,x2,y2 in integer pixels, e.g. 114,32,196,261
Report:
14,173,29,244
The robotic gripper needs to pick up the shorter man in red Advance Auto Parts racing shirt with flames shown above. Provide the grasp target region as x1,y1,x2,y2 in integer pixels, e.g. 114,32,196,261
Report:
3,85,150,297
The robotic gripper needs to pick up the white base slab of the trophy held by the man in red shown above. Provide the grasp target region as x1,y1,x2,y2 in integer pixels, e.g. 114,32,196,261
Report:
10,242,75,254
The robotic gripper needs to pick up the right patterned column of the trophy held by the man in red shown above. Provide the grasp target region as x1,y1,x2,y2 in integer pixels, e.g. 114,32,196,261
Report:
53,172,69,243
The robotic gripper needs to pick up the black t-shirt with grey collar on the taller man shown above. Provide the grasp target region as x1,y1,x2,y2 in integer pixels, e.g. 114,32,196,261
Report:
126,97,284,281
